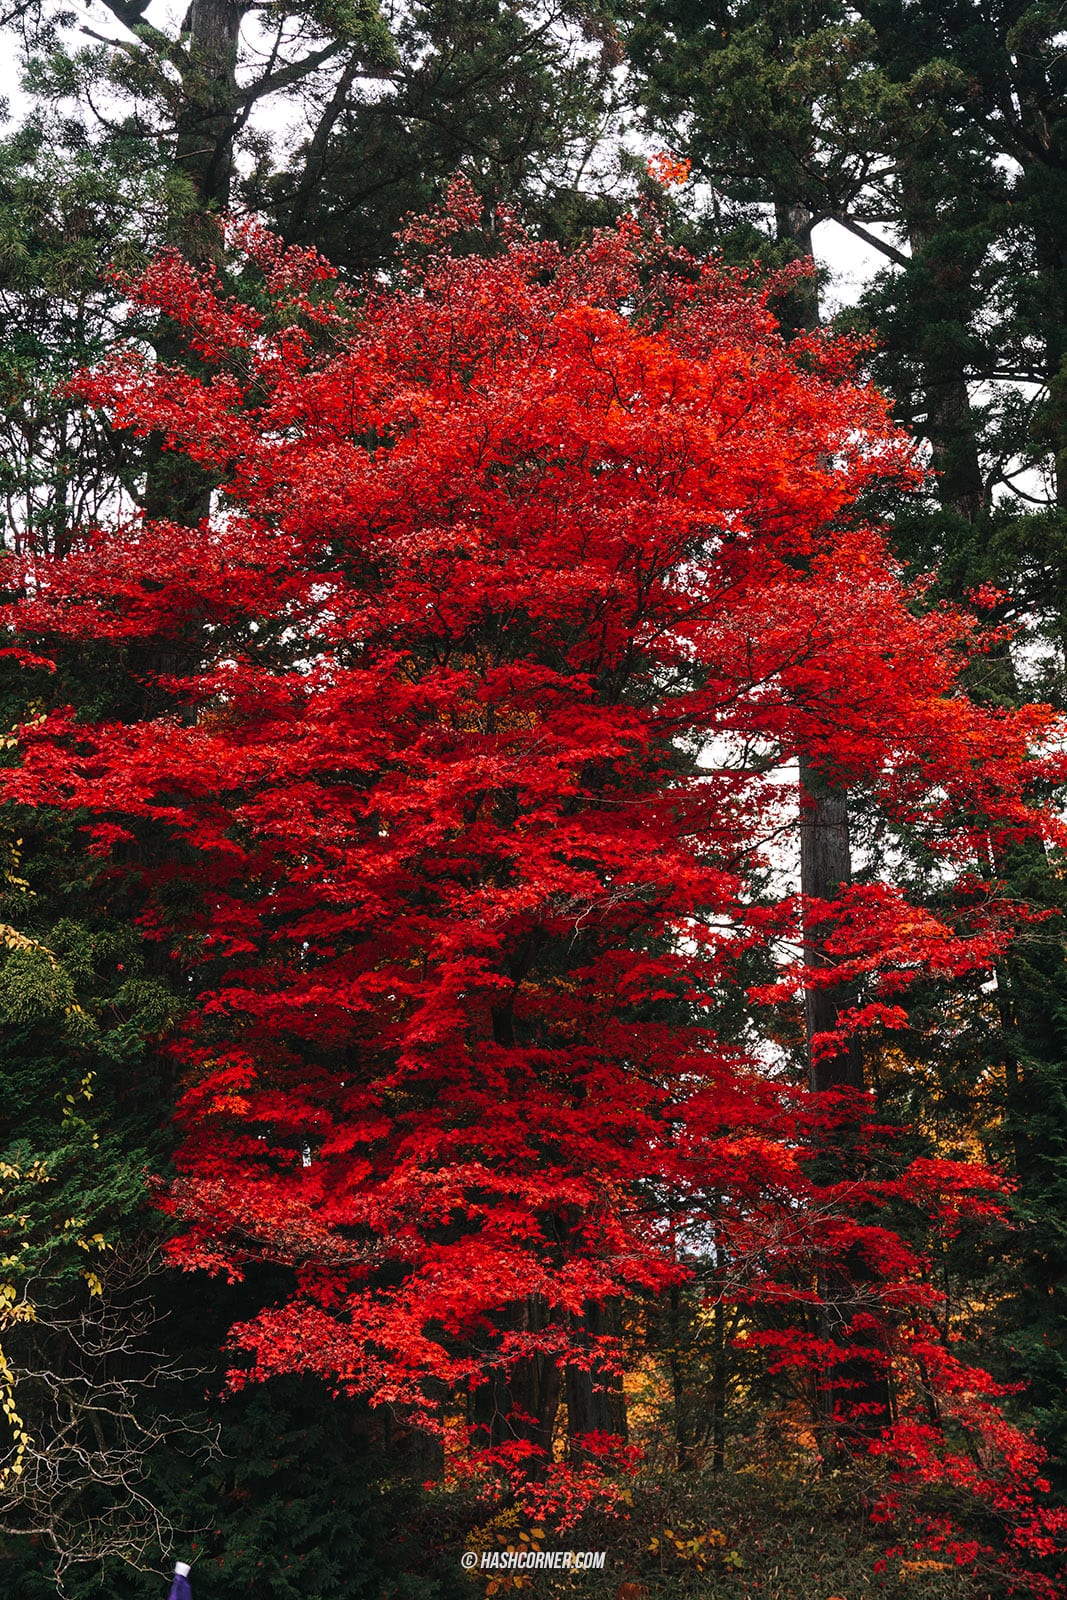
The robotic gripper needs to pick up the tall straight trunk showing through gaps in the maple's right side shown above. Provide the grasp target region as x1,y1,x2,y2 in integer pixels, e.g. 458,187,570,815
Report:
774,198,889,1456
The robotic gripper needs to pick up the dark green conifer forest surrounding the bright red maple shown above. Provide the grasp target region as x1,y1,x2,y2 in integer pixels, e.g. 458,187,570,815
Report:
0,0,1067,1600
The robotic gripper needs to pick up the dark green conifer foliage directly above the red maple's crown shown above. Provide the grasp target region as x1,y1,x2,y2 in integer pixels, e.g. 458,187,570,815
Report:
265,0,619,272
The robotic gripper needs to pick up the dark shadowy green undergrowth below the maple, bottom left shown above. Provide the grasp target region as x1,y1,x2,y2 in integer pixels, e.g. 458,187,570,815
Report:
0,1369,469,1600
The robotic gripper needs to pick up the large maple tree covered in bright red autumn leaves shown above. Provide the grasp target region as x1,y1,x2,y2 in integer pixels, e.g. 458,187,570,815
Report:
3,187,1054,1574
